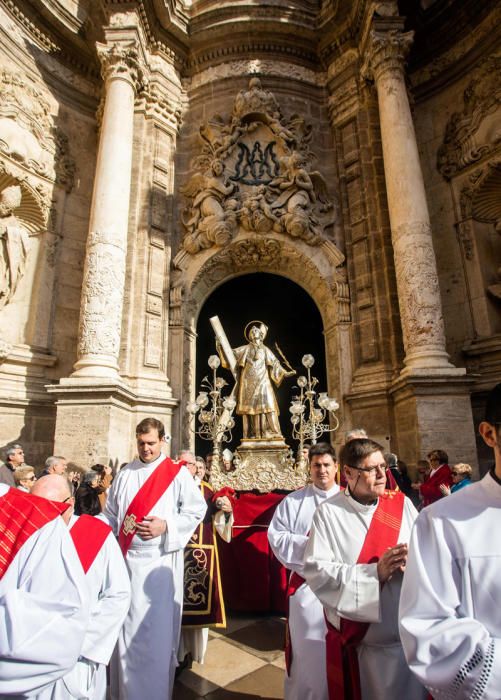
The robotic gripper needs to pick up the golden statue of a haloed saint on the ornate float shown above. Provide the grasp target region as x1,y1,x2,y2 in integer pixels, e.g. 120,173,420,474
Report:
217,321,295,440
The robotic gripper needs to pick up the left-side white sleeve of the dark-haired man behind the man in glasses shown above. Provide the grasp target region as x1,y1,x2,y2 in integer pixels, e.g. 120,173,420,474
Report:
268,498,308,576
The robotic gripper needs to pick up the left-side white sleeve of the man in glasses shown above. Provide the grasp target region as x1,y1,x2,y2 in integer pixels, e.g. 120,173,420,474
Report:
303,503,381,622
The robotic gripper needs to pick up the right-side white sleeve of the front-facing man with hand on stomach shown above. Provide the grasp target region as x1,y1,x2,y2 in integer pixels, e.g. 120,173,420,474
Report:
164,468,207,553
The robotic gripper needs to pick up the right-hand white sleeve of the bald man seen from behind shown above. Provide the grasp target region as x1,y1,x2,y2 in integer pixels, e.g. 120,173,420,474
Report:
82,532,131,664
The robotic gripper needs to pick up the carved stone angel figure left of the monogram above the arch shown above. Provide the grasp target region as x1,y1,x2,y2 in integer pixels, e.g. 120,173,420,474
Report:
181,158,237,253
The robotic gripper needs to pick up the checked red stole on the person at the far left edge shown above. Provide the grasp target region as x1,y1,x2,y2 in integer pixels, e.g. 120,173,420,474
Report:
0,488,68,579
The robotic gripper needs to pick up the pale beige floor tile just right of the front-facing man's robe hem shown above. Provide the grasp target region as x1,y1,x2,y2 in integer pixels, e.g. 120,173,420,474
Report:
191,639,265,687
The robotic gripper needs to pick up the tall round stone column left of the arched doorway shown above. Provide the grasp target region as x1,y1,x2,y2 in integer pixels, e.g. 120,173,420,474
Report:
72,42,142,380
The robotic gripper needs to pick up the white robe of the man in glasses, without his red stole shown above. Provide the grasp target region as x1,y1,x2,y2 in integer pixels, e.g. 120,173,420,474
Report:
303,490,426,700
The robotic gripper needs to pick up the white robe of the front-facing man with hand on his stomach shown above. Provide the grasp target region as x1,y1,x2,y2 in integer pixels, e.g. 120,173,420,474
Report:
104,455,207,700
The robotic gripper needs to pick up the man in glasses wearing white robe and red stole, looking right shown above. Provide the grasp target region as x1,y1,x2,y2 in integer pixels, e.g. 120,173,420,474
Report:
303,438,426,700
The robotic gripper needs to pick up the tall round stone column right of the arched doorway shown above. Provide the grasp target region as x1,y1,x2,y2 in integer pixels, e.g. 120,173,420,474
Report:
363,29,452,375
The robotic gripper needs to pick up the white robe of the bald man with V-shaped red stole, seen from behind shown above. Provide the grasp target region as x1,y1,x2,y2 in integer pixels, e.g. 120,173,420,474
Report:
44,515,130,700
